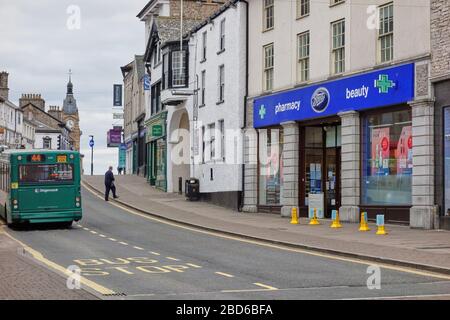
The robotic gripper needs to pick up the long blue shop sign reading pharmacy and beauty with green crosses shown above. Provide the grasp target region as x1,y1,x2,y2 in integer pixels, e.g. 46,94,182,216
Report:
253,63,414,128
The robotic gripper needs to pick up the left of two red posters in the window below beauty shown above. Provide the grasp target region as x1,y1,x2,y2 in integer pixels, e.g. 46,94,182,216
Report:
372,128,390,176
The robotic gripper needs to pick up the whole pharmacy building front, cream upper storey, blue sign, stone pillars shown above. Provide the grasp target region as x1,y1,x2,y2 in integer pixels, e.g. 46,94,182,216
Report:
244,0,437,229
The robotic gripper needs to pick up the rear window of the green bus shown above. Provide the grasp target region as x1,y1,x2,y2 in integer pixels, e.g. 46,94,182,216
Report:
19,163,73,184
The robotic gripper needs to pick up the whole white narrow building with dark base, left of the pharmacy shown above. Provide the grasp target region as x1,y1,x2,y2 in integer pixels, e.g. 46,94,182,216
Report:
187,1,247,209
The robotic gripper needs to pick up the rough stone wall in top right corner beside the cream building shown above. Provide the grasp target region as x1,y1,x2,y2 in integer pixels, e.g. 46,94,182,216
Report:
431,0,450,78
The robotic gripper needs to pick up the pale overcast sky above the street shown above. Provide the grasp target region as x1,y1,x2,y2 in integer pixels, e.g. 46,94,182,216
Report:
0,0,147,174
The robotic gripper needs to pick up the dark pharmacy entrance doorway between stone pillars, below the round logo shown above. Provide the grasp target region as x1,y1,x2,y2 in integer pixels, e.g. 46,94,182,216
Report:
299,122,341,218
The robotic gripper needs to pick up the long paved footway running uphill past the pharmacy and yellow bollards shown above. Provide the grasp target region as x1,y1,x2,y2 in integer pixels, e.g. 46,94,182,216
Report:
83,175,450,274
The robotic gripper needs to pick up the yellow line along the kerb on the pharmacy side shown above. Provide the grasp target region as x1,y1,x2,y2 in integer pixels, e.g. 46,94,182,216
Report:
81,182,450,280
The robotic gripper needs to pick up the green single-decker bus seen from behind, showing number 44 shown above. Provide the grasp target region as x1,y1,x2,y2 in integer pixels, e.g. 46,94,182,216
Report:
0,150,82,228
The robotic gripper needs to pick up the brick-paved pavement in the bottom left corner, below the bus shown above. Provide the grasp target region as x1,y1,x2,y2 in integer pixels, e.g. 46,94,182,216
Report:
0,223,96,300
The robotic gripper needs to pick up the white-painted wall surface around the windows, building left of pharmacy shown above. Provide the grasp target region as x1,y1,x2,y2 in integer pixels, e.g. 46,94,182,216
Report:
188,2,246,193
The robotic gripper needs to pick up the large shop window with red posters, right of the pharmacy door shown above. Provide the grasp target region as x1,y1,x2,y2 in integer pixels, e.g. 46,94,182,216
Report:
361,110,413,206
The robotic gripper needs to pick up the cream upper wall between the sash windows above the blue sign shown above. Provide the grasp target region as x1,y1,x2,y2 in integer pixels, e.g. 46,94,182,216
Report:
249,0,430,97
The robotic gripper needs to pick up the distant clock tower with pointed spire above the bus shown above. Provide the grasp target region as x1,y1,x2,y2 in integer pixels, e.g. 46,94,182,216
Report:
62,70,81,151
